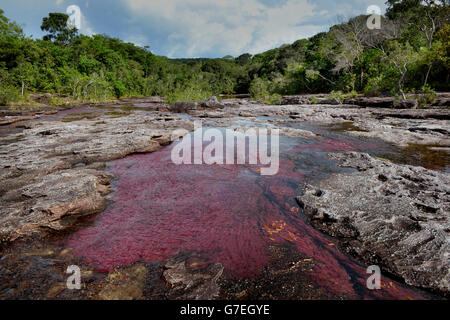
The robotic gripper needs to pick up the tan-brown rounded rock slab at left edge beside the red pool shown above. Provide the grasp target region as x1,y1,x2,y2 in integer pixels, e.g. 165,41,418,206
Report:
0,169,113,242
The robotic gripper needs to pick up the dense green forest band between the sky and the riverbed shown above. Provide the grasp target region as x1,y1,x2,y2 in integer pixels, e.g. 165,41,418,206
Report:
0,0,450,104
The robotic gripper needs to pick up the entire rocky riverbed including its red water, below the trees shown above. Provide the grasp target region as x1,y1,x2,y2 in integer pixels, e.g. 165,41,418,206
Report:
0,98,450,299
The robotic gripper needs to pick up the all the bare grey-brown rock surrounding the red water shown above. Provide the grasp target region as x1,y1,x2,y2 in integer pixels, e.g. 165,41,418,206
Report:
0,95,450,299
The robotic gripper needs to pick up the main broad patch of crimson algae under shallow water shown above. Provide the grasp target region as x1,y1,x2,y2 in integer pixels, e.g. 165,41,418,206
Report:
69,149,301,277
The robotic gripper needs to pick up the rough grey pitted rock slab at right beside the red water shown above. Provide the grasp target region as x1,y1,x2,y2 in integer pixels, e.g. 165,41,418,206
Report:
298,153,450,295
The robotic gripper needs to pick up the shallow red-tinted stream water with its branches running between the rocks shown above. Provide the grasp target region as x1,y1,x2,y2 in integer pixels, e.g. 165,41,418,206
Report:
66,123,432,299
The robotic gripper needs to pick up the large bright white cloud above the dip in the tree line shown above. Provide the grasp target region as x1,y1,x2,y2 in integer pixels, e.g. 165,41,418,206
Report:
122,0,323,56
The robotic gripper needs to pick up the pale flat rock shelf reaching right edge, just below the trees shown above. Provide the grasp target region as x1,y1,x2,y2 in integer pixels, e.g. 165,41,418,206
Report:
236,105,450,147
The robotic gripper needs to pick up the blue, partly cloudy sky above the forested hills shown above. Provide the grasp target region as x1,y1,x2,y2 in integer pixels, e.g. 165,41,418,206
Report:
0,0,386,58
